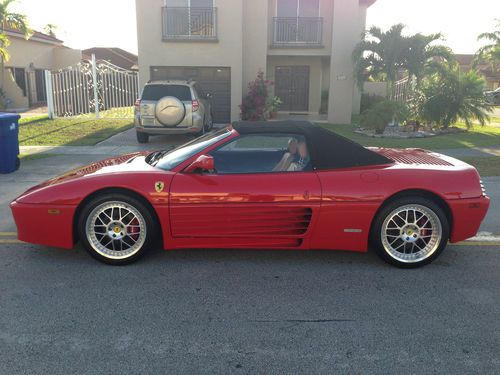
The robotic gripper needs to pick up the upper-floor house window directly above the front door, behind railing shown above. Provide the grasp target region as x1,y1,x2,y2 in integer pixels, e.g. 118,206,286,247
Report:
273,0,323,47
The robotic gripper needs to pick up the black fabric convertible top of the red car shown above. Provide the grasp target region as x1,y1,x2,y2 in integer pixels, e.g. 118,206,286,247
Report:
233,121,394,170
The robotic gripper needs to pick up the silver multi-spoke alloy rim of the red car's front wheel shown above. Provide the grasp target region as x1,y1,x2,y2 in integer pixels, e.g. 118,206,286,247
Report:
85,201,147,259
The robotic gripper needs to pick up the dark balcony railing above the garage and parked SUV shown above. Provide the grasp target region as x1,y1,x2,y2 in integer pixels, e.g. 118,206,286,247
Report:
162,7,217,41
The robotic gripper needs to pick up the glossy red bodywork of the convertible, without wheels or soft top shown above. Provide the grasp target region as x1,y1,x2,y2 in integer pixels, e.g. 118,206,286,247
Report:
11,130,489,251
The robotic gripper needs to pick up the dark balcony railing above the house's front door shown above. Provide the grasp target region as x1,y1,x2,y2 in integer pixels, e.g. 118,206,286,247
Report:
271,17,323,48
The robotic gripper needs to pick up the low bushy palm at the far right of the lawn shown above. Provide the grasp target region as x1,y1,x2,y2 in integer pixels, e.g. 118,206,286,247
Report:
415,64,492,128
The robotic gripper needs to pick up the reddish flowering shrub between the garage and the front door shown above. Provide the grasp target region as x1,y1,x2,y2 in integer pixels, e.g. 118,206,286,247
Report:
240,72,273,121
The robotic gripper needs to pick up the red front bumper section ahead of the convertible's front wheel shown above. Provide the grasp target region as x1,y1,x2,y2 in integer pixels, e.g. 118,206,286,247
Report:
10,201,76,249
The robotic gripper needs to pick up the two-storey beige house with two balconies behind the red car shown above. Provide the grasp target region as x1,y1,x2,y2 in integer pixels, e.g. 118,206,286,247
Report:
136,0,375,123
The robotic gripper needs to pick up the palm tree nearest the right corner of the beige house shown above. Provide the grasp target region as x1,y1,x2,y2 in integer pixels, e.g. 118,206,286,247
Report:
353,24,406,94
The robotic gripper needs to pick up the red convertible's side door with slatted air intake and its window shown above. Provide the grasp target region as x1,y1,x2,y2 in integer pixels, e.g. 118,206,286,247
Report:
170,135,321,248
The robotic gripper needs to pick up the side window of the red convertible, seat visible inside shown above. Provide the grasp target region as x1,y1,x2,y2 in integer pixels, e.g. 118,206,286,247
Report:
210,133,312,174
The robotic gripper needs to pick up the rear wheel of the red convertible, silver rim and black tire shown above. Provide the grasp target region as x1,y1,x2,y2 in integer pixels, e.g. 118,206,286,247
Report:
371,197,450,268
